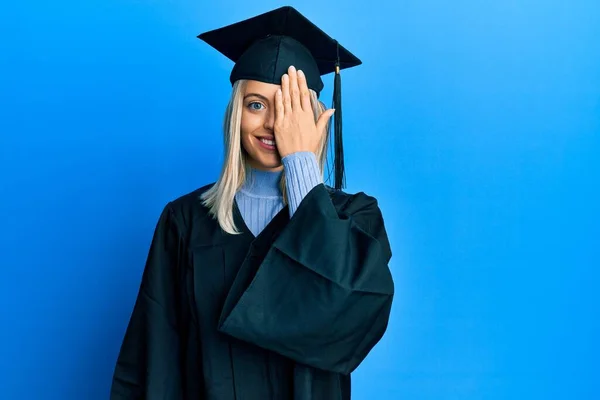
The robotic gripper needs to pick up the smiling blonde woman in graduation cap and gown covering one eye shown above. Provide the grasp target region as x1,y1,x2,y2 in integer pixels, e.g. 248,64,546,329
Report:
111,7,394,400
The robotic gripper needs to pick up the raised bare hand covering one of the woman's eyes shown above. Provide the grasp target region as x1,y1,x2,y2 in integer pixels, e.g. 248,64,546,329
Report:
274,66,335,158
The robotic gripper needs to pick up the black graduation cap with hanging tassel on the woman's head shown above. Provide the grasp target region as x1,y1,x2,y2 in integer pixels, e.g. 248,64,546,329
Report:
198,6,362,189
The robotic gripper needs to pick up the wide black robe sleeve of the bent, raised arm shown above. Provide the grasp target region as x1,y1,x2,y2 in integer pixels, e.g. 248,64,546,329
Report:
219,184,394,374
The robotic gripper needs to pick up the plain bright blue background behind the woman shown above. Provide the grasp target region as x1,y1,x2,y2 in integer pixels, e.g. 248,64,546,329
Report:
0,0,600,400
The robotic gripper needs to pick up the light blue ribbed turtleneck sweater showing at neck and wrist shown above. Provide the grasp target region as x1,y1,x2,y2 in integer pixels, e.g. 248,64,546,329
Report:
235,151,323,236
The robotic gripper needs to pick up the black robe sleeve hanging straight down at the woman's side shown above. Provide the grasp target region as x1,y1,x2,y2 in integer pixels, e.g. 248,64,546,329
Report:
110,205,183,400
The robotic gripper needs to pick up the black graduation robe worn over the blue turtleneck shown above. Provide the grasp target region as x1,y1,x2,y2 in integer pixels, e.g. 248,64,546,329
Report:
111,184,394,400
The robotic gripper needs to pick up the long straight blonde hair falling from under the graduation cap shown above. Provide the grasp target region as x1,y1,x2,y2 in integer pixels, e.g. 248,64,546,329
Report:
200,79,329,235
